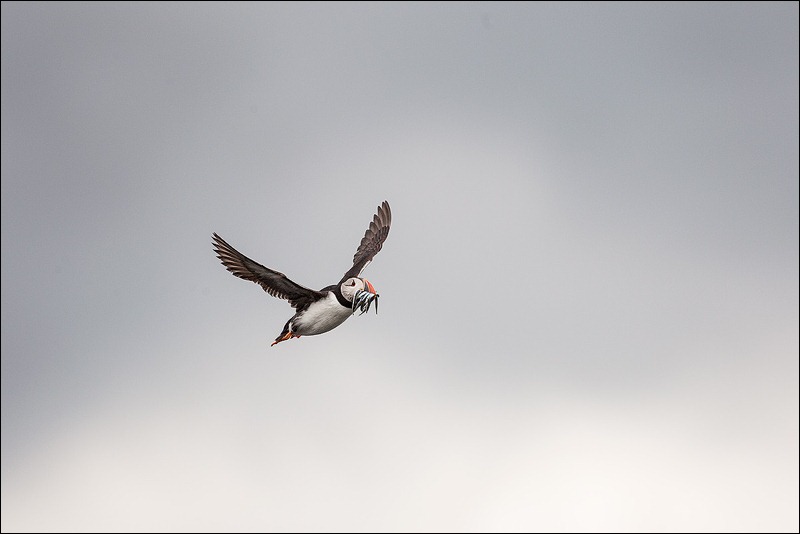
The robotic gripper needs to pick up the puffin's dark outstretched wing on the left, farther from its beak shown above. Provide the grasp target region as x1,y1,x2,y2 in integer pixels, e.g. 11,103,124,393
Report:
212,233,325,310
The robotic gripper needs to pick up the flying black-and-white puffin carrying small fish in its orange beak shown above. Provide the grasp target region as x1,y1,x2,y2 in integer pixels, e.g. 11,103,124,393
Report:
211,200,392,347
